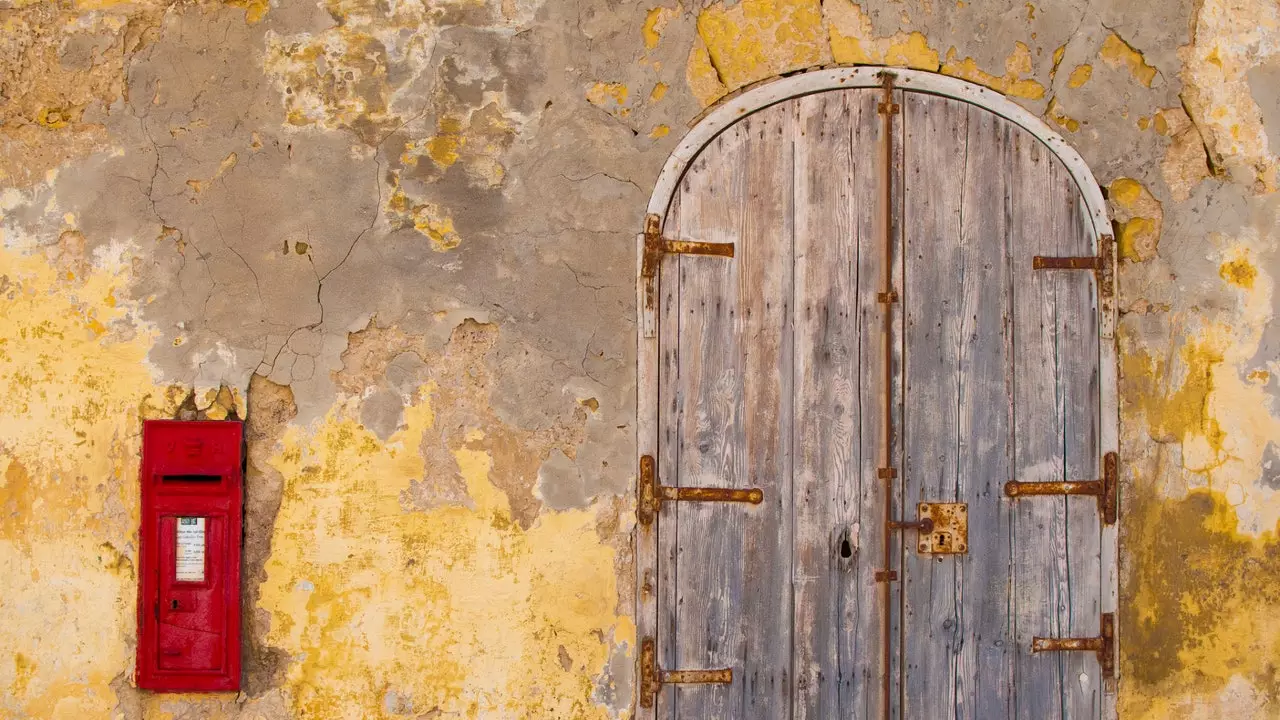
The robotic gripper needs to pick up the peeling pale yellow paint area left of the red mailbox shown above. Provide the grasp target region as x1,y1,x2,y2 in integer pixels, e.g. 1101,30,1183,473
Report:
0,240,175,717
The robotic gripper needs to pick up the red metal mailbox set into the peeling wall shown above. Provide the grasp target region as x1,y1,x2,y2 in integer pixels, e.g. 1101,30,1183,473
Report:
137,420,244,691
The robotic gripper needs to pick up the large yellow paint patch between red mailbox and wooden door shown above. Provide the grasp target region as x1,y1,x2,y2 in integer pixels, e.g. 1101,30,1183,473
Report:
261,384,634,720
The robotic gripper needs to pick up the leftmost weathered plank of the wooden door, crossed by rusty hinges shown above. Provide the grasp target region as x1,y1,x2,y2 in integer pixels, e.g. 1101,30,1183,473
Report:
662,124,748,717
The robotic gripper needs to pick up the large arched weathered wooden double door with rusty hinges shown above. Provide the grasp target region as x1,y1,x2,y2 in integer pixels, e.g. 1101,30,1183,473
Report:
637,69,1115,720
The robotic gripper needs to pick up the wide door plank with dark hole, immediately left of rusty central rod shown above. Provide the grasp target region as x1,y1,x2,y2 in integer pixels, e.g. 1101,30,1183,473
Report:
792,90,883,720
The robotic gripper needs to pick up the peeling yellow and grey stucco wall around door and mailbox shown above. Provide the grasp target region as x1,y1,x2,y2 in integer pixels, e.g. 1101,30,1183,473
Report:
0,0,1280,719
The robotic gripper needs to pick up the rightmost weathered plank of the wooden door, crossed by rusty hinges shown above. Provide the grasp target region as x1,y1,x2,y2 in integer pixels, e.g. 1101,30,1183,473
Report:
1006,135,1101,719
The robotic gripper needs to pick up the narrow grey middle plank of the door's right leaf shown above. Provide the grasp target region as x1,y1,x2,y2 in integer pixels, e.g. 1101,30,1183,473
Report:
951,105,1018,720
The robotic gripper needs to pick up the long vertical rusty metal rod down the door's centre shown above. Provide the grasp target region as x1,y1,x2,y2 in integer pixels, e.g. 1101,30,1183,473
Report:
879,72,897,720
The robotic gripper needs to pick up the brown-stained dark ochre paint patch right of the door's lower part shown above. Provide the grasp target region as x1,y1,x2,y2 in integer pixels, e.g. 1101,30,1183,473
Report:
1120,478,1280,720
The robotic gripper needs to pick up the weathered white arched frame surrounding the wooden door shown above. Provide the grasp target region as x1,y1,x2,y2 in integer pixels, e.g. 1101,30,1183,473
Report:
635,65,1124,720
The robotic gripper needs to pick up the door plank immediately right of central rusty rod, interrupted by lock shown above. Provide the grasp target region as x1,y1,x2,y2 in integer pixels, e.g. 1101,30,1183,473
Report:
900,94,969,719
